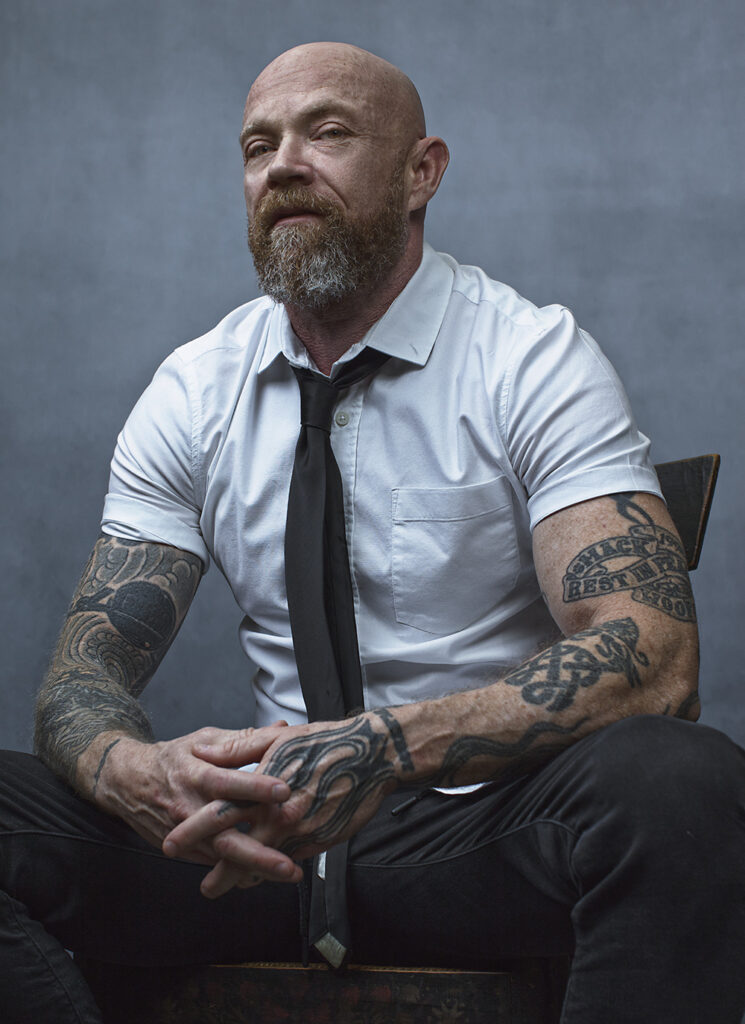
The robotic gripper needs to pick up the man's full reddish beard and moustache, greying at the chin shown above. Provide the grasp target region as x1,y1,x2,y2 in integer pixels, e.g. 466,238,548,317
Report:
249,170,408,309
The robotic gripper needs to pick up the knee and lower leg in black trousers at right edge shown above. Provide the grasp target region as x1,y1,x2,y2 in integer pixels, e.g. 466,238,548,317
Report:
563,717,745,1024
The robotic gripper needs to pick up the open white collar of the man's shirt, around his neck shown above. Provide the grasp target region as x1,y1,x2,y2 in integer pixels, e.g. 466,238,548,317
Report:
259,243,453,376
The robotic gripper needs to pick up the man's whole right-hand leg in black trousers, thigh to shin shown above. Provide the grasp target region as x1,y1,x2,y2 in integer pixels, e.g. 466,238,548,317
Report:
351,716,745,1024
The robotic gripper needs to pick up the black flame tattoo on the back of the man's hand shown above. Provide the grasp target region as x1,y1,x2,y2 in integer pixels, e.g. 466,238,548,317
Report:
266,713,396,856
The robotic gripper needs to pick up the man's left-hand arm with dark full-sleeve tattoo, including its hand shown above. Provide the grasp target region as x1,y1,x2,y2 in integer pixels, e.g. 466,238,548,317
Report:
36,537,297,877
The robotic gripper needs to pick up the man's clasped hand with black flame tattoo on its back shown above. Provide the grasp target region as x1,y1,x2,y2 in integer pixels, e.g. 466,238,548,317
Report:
164,713,396,897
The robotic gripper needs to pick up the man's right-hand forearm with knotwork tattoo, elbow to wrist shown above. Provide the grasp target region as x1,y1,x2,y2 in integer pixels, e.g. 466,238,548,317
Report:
388,615,698,786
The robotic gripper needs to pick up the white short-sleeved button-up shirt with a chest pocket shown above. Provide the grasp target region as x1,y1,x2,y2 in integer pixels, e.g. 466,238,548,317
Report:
102,247,660,725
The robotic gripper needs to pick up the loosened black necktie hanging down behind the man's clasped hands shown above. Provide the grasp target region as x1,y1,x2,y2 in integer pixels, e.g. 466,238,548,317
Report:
284,348,388,967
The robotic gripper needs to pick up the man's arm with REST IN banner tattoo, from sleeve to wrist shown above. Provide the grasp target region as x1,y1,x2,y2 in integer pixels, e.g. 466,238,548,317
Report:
395,495,698,784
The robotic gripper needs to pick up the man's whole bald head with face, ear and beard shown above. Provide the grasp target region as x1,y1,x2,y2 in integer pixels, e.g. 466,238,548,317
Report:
240,43,447,327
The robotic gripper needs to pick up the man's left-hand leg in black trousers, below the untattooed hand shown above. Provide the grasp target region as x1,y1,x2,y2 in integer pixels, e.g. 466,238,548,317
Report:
0,753,300,1024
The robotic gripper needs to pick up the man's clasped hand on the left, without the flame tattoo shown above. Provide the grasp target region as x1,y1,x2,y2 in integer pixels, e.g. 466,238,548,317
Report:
96,722,300,885
